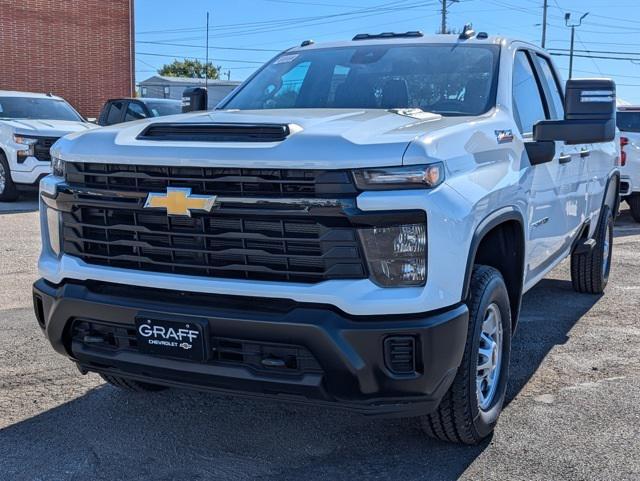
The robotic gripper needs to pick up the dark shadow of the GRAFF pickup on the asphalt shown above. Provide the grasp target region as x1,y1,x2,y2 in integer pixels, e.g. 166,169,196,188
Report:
0,214,636,481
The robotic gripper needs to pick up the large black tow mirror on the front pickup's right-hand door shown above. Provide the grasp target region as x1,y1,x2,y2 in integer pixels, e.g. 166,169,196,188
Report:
533,79,616,145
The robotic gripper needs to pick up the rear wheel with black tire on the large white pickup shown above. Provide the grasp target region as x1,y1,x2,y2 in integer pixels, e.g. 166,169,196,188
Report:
571,206,614,294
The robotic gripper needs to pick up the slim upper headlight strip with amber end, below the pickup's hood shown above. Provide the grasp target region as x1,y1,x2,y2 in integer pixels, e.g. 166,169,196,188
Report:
353,162,444,190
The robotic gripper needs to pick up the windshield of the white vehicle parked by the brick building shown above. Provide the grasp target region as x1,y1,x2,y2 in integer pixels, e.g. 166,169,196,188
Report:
0,97,83,122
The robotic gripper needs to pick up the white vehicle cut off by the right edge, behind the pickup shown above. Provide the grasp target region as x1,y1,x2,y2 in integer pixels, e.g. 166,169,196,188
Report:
617,105,640,222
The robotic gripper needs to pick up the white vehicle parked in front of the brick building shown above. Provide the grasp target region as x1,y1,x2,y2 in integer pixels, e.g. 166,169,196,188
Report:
0,90,96,202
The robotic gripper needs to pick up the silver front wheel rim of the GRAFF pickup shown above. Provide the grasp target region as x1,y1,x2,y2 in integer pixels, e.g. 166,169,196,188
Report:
476,303,503,411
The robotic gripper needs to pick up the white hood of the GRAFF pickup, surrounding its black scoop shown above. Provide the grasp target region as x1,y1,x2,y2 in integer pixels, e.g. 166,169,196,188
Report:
53,109,476,169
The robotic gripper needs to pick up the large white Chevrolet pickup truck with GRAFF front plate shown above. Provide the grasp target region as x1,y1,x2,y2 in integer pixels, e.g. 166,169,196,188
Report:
34,30,620,444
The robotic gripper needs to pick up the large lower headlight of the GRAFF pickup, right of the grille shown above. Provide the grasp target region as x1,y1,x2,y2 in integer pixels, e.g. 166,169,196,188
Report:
359,224,427,287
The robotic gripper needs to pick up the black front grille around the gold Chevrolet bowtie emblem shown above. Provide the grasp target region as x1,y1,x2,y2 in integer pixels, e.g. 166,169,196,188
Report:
62,164,368,283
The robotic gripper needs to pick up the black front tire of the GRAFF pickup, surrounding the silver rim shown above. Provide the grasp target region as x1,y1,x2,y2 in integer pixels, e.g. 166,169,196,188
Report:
421,265,511,444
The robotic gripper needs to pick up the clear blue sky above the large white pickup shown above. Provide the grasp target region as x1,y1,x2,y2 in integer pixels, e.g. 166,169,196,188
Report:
135,0,640,104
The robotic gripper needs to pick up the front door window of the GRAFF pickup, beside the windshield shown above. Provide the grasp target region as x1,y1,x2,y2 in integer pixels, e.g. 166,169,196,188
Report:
513,50,547,135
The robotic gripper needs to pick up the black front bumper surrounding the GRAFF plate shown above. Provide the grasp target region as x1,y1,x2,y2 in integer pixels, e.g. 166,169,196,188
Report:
34,280,468,415
